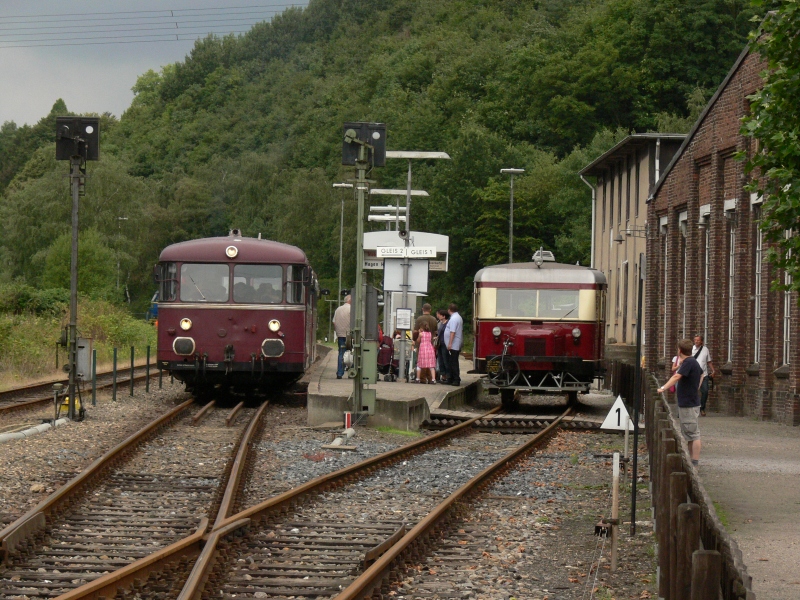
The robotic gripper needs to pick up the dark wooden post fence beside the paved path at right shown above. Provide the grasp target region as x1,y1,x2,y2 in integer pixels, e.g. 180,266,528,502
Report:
644,367,755,600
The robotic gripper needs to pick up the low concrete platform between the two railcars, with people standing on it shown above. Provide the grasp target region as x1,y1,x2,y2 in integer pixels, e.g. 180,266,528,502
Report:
307,350,480,430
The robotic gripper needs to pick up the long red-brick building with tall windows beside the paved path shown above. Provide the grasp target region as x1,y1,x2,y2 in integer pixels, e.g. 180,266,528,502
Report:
645,44,800,425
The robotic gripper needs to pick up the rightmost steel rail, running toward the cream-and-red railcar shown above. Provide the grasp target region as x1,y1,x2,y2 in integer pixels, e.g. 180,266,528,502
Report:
334,408,572,600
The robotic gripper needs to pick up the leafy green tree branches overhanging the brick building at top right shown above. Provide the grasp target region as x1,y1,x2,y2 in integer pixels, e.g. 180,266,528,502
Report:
742,0,800,290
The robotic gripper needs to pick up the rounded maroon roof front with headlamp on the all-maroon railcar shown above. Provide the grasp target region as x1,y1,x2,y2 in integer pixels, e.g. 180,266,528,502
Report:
159,235,308,264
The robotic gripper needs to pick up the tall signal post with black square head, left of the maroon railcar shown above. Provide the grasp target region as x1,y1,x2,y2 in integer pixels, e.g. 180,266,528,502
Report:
56,117,100,420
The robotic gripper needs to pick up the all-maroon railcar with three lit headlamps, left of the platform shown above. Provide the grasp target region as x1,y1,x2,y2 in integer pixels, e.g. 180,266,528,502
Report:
156,229,319,393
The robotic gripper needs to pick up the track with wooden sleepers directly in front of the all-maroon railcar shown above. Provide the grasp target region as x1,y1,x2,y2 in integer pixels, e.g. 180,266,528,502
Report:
0,401,266,598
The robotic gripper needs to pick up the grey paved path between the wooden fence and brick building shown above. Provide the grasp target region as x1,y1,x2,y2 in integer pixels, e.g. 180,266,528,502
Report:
700,413,800,600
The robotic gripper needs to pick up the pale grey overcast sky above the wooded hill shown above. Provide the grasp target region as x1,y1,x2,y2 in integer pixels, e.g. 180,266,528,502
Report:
0,0,308,125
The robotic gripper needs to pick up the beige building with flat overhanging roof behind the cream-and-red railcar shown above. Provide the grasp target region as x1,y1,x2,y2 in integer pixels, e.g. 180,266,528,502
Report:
580,133,686,363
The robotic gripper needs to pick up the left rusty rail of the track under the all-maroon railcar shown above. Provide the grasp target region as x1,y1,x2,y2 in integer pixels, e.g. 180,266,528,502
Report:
0,399,194,562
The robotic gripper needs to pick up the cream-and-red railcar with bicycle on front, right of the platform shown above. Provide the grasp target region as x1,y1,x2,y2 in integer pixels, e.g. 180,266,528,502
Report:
474,252,606,404
